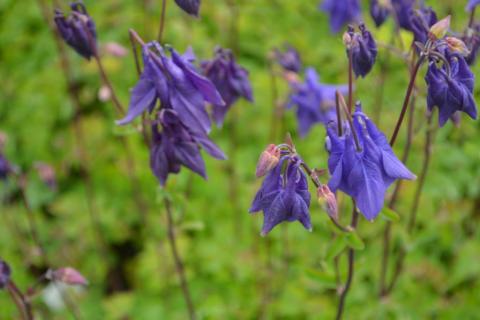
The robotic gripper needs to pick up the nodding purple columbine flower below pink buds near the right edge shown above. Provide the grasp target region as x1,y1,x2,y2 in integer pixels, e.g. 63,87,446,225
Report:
425,50,477,126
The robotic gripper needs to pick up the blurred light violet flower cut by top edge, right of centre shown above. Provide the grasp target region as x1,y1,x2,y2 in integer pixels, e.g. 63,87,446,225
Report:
320,0,362,33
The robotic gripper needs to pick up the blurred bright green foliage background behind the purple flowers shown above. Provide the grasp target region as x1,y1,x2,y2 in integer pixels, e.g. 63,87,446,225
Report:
0,0,480,319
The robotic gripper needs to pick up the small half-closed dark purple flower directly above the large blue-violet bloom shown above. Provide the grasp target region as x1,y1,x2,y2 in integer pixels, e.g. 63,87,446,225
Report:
344,23,378,78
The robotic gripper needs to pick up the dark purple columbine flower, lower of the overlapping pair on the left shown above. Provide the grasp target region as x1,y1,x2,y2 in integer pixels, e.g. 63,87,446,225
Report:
150,108,226,185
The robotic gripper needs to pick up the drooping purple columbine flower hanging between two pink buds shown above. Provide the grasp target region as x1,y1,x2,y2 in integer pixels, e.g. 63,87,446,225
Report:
250,156,312,236
